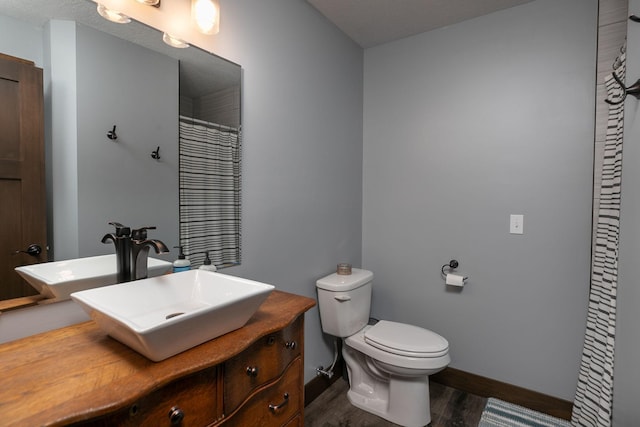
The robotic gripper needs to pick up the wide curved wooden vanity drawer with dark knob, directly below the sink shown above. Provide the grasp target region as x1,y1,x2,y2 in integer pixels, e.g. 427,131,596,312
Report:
80,367,222,427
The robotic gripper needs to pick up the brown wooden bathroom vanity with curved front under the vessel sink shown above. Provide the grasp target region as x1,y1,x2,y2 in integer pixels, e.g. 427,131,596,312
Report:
0,291,315,427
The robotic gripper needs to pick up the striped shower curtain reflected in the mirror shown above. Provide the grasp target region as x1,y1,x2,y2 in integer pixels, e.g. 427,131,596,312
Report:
179,116,241,268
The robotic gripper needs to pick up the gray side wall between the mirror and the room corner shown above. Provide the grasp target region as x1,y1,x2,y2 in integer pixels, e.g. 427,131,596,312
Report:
211,0,363,381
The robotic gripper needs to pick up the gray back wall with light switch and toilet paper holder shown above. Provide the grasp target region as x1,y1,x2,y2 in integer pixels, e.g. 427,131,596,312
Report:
363,0,597,400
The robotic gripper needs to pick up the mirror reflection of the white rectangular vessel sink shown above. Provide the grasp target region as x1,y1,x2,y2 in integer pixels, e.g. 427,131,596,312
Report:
15,254,172,300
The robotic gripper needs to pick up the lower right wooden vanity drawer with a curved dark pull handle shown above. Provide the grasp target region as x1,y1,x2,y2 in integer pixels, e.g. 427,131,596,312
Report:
222,357,304,427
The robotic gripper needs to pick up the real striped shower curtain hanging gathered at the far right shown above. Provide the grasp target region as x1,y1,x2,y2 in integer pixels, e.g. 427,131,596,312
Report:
571,47,625,427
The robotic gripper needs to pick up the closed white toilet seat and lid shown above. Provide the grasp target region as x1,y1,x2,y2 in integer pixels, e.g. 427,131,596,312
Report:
364,320,449,358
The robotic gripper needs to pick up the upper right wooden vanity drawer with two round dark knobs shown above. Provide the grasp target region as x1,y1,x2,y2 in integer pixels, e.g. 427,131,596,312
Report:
224,317,303,414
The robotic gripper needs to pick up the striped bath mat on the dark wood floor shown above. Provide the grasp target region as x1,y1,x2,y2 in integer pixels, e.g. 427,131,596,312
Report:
478,397,571,427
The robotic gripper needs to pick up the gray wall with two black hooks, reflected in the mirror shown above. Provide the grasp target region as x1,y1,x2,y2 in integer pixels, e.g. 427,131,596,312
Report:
76,25,179,259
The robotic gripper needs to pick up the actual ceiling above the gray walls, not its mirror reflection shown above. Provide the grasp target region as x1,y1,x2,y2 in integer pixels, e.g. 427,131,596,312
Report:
307,0,533,49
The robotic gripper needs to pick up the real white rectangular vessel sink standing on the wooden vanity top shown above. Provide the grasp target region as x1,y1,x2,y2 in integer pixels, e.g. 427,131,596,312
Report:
71,270,274,362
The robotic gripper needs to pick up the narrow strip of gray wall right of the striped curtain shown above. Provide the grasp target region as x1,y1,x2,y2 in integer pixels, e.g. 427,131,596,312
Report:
613,0,640,427
